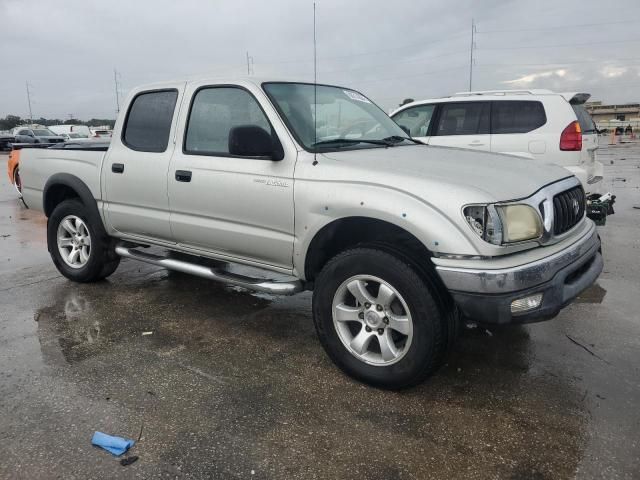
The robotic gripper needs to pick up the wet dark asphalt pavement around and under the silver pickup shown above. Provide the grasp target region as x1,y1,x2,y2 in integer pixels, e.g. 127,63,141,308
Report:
0,144,640,480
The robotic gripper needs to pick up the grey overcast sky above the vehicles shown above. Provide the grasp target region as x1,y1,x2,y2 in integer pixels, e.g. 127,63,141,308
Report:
0,0,640,119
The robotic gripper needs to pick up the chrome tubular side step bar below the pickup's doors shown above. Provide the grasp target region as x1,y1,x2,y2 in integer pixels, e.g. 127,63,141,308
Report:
116,245,304,295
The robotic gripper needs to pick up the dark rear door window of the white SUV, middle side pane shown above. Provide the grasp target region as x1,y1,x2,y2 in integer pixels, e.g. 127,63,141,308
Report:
434,102,490,136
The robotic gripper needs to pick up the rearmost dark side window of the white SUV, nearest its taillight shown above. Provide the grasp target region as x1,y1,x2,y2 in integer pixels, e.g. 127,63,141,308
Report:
491,100,547,134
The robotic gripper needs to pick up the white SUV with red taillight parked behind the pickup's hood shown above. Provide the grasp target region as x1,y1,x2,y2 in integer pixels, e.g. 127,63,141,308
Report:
391,90,602,193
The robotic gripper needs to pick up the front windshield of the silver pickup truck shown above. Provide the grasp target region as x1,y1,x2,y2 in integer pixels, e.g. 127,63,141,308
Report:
264,83,412,151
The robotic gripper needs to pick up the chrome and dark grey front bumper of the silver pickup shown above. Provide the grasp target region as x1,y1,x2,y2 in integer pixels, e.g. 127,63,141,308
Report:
436,226,603,324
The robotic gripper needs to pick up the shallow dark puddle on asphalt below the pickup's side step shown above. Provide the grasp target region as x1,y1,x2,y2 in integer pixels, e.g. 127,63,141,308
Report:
34,274,271,365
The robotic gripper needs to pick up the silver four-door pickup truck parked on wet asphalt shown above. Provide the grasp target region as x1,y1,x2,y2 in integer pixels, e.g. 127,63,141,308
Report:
21,79,602,388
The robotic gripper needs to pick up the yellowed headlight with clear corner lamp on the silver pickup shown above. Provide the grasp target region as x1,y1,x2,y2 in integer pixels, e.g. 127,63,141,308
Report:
463,205,542,245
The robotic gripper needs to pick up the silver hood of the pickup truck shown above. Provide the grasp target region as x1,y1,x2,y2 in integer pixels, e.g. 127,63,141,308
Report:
323,145,571,202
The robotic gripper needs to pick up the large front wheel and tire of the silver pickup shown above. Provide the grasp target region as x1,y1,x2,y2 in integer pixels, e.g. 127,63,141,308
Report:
313,247,448,390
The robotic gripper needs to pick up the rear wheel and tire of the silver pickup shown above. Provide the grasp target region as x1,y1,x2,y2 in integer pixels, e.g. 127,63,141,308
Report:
47,199,120,283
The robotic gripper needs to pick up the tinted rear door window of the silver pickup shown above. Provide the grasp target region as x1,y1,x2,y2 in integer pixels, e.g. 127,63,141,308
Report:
122,90,178,152
